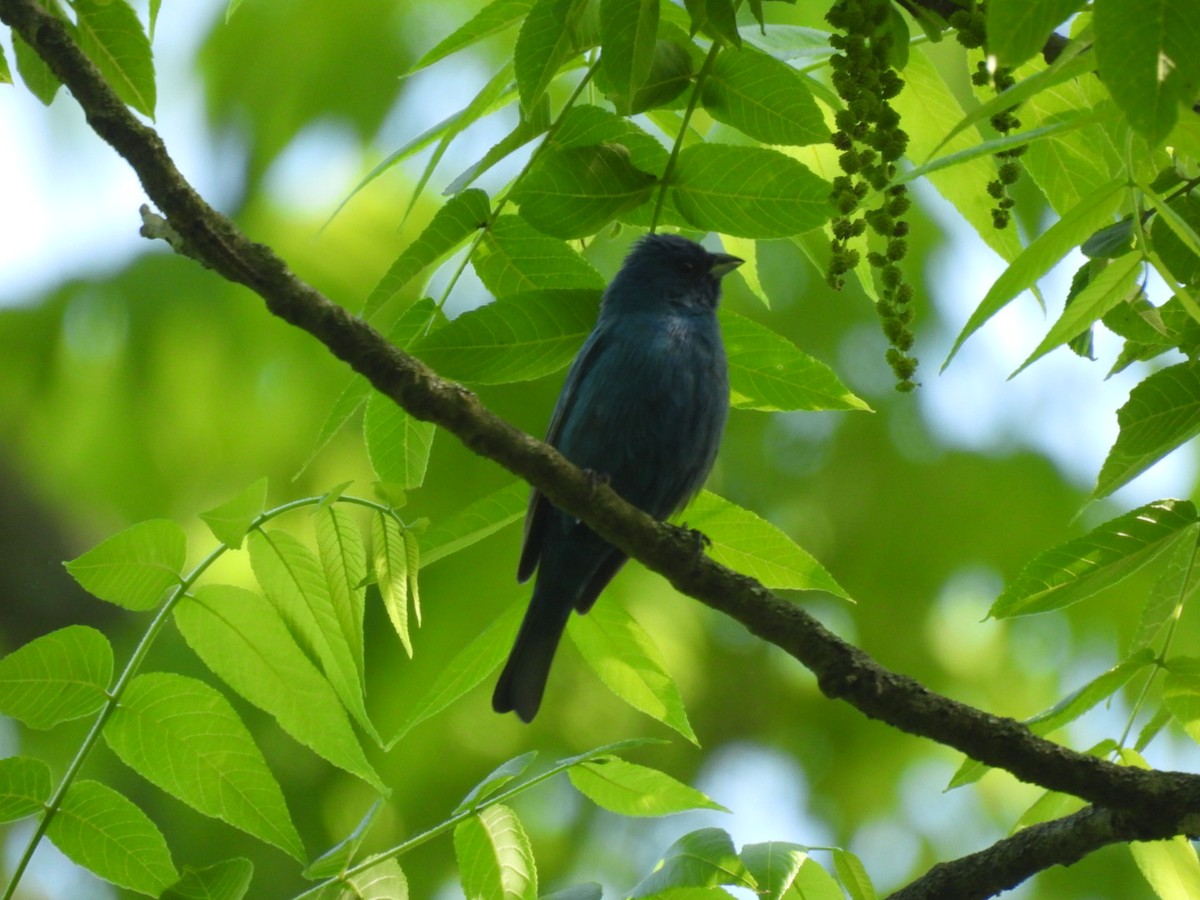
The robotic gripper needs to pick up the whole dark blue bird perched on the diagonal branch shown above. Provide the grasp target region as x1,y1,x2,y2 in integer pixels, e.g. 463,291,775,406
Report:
492,234,743,722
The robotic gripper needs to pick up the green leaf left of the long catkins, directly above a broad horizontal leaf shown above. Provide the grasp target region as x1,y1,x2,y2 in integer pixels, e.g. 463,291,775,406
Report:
701,47,829,145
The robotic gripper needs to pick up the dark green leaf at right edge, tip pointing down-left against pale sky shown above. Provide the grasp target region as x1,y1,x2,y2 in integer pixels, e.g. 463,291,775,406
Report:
1092,360,1200,498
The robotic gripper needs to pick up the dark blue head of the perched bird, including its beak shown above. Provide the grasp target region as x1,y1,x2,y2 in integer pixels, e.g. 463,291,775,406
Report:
605,234,743,312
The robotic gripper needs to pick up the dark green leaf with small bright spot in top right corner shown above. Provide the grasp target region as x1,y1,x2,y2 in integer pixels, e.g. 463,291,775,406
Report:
1093,0,1200,144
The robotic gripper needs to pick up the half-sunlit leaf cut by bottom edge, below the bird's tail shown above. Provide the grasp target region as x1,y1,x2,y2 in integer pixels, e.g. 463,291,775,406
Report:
454,804,538,900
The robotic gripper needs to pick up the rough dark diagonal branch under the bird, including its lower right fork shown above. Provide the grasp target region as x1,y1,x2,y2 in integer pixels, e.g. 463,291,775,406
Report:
0,0,1200,896
